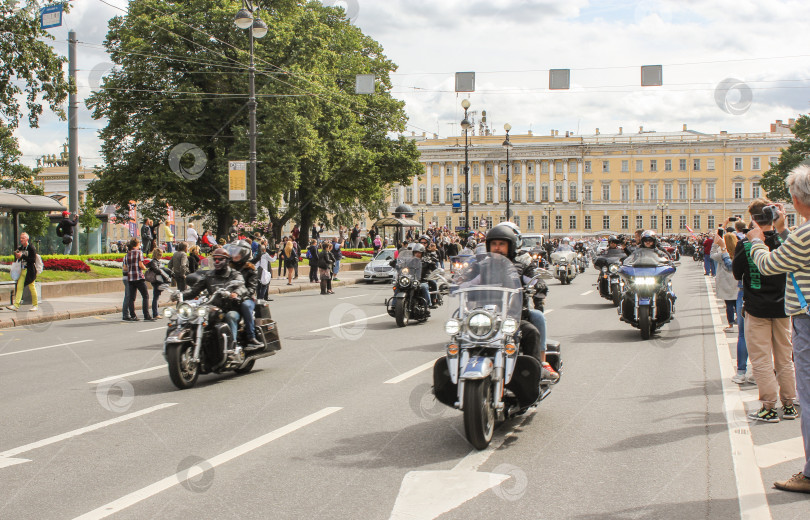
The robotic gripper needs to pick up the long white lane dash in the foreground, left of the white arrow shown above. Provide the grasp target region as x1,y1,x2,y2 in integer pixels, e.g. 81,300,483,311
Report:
74,407,343,520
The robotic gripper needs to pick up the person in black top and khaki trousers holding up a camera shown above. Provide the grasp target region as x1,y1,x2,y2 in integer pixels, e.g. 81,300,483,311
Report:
732,198,798,423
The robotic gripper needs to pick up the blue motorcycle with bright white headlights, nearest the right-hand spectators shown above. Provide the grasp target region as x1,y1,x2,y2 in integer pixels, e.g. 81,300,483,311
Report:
618,248,676,339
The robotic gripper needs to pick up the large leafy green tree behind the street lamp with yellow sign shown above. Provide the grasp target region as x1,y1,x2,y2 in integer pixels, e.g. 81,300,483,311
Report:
88,0,422,244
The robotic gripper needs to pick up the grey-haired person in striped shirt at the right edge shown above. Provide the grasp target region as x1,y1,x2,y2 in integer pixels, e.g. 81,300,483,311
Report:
748,165,810,493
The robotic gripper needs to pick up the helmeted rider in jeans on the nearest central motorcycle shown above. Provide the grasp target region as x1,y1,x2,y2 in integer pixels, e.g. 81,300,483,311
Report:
486,225,560,380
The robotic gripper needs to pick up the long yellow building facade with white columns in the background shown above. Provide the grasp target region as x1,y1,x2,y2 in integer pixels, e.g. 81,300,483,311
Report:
389,125,797,237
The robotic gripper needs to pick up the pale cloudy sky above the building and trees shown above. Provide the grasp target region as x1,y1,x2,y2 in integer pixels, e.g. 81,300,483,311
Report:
11,0,810,166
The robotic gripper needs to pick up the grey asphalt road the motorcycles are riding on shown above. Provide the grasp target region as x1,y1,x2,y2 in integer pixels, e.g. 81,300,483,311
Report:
0,260,810,520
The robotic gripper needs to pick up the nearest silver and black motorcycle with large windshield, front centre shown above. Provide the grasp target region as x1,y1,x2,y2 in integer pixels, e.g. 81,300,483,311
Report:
433,253,562,450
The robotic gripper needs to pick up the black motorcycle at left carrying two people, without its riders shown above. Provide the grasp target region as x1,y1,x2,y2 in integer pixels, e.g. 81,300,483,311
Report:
163,266,281,390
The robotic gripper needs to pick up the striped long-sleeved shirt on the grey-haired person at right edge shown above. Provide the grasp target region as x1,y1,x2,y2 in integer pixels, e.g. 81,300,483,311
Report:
751,221,810,316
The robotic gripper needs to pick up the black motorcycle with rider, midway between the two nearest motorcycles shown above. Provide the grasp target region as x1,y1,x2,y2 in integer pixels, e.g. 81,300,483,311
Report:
385,249,432,327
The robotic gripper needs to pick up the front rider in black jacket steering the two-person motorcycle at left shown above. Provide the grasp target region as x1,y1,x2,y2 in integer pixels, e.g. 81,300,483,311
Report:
178,247,248,350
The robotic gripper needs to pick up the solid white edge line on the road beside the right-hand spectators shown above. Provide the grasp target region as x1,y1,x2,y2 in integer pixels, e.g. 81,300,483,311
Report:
704,279,772,520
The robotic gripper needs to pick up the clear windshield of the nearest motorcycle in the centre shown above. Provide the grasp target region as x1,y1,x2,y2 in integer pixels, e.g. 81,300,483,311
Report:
450,253,523,321
